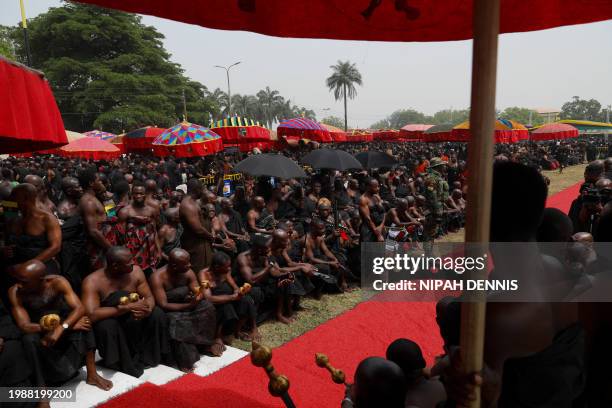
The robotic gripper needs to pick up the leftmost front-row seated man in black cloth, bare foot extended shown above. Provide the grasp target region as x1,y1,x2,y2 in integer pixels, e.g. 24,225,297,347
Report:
9,260,113,396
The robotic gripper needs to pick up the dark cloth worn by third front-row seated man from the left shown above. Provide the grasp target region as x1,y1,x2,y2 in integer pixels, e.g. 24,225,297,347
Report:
166,286,216,368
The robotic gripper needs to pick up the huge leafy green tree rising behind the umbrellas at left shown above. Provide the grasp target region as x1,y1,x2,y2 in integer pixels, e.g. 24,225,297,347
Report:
11,3,219,132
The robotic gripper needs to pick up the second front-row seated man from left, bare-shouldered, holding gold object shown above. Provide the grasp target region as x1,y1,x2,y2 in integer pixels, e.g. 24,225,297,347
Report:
82,246,170,377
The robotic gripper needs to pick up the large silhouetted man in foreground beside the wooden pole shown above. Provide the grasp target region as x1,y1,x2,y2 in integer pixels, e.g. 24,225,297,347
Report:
446,162,585,407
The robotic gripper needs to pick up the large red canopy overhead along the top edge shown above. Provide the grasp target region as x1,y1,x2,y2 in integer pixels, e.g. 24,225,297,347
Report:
74,0,612,41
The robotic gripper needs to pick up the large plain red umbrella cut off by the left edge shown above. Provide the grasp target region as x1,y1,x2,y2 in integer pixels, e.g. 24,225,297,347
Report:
0,56,68,153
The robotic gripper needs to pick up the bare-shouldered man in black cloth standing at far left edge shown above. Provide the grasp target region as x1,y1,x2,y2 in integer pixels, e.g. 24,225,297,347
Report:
4,183,62,276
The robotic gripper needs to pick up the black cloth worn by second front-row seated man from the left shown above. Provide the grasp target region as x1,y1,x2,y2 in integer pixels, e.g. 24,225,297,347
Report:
93,290,171,377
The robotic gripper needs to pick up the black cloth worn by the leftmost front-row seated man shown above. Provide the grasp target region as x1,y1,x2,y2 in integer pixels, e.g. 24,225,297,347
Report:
21,294,96,387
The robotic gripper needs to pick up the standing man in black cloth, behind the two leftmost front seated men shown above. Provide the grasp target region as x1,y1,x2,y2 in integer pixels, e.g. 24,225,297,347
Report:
57,177,89,293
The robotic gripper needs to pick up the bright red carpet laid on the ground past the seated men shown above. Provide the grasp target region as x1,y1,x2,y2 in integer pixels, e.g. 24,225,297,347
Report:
102,184,580,408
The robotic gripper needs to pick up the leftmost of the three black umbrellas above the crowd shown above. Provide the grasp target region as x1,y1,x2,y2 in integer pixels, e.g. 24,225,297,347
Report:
234,153,306,180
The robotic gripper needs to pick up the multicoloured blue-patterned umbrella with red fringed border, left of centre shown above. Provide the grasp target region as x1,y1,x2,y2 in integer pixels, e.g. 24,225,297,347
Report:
153,122,223,157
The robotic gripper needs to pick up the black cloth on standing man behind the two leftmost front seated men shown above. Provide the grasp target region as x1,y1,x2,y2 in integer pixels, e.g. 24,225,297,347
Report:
58,215,89,293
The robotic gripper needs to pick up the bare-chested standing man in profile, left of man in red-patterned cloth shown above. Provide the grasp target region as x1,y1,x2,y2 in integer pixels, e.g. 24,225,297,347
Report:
79,168,117,270
